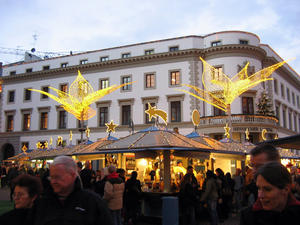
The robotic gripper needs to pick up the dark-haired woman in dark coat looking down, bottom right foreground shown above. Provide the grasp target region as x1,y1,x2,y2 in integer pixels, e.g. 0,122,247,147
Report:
240,162,300,225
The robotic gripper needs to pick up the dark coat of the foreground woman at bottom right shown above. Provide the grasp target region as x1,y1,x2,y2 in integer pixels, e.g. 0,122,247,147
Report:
240,193,300,225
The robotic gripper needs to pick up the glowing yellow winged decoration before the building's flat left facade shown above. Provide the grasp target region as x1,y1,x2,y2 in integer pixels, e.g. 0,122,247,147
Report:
29,70,132,121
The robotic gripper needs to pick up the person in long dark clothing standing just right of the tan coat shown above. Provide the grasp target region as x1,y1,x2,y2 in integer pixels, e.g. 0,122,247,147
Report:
124,171,142,225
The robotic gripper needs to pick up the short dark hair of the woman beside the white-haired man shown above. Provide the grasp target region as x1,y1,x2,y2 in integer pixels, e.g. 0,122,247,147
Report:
13,174,43,197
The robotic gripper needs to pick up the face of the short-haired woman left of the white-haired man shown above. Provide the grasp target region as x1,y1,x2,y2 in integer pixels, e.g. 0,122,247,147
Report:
13,186,36,209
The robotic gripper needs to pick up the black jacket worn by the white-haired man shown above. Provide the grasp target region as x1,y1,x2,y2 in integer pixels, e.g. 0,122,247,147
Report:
32,179,113,225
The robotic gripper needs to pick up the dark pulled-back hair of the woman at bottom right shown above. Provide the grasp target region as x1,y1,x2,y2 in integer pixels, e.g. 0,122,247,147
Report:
255,162,292,189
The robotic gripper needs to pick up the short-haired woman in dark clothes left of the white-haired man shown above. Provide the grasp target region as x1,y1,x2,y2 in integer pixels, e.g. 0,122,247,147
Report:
0,174,42,225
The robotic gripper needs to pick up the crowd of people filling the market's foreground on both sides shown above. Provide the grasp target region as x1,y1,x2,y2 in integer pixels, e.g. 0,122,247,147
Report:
0,145,300,225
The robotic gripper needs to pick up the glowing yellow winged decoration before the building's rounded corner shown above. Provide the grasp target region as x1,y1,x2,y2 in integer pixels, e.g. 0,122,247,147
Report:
179,57,286,112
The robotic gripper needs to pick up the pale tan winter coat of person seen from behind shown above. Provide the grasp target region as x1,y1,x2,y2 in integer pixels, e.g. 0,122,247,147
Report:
103,173,125,210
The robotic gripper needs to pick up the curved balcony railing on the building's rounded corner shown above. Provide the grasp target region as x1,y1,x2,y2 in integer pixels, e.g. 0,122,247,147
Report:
199,114,278,126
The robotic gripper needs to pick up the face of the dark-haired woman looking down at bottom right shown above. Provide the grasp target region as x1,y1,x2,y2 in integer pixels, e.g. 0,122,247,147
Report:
256,175,289,212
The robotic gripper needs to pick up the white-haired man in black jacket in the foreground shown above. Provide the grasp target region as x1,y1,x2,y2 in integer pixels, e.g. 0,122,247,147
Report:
31,156,113,225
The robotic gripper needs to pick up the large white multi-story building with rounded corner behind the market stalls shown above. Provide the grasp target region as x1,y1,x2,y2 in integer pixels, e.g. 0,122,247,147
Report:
0,31,300,159
